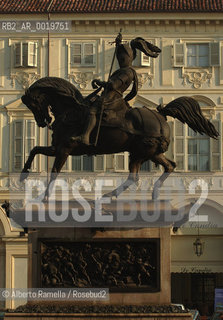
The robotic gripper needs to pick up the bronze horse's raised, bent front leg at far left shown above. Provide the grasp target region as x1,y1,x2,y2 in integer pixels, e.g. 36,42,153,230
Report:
20,146,55,181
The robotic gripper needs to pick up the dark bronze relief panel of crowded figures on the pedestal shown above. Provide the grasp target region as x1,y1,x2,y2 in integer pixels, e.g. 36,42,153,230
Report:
40,239,160,292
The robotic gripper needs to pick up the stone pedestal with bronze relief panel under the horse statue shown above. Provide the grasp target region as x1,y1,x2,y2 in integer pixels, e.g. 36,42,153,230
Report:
5,201,191,320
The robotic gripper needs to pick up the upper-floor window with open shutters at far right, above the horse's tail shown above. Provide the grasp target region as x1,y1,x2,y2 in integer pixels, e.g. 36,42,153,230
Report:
174,42,220,68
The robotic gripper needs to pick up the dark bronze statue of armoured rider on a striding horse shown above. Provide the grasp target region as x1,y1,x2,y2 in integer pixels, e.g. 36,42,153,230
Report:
20,36,219,199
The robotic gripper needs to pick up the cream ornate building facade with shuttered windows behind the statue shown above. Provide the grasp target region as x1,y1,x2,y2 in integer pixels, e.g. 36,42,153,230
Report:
0,0,223,314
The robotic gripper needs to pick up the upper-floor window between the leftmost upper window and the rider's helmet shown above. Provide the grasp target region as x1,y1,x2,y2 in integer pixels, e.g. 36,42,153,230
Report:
70,42,95,66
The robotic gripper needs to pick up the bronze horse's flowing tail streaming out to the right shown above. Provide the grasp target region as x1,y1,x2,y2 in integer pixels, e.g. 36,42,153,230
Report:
157,97,219,139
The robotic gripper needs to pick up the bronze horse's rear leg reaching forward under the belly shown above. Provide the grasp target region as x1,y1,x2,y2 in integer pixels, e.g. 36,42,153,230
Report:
103,155,142,198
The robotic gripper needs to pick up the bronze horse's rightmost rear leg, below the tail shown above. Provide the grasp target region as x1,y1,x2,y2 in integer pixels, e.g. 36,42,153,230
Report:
151,153,176,200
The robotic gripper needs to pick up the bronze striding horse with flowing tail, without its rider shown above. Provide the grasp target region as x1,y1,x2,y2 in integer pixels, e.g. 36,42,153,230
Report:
21,77,219,199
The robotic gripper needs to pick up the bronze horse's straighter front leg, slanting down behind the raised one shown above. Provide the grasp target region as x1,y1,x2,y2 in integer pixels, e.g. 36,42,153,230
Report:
45,148,71,199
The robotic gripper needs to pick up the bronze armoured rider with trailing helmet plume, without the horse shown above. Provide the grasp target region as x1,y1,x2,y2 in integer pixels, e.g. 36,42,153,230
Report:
71,33,161,145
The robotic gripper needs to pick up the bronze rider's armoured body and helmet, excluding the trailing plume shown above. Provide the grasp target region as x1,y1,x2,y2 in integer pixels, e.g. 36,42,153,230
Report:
71,33,138,145
